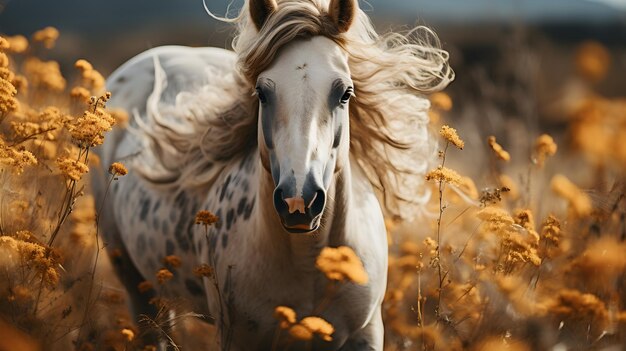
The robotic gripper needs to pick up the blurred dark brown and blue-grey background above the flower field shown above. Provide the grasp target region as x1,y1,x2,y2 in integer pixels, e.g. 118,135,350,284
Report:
0,0,626,139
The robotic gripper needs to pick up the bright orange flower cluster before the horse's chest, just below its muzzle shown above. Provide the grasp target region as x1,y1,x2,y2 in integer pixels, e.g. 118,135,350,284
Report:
315,246,368,285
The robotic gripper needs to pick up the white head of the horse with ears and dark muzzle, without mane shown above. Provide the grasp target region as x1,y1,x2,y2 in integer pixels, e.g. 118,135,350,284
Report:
249,0,356,233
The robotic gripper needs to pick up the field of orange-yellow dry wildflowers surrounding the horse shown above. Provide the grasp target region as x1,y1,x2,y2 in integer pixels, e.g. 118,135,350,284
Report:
0,28,626,350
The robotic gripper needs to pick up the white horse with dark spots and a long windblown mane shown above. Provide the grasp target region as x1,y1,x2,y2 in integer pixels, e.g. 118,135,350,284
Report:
93,0,452,350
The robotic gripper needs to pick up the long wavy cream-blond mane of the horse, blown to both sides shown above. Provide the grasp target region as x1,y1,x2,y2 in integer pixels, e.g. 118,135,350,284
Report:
138,0,453,217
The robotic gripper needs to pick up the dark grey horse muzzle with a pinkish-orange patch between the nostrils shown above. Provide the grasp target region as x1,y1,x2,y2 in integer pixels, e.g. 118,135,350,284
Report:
274,185,326,233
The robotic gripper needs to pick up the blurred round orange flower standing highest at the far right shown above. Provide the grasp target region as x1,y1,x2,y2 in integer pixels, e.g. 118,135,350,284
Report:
576,41,611,82
